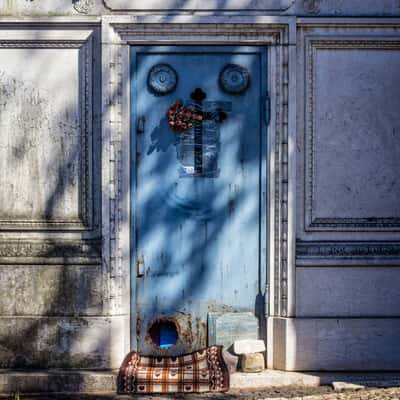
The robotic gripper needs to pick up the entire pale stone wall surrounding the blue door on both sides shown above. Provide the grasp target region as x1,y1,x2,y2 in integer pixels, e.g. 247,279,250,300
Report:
0,0,400,378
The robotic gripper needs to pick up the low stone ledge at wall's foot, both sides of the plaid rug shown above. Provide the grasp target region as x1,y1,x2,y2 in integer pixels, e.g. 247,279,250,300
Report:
0,369,400,394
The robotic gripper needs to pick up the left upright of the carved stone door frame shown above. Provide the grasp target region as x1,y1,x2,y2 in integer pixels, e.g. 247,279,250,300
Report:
102,28,131,368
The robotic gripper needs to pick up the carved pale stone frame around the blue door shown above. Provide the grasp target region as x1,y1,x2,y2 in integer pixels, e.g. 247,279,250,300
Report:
102,15,296,368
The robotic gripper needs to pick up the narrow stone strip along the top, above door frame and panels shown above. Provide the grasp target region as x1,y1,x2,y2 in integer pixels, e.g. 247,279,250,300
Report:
0,0,400,17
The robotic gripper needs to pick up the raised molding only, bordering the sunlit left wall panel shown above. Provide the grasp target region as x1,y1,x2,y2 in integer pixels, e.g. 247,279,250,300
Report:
0,27,96,231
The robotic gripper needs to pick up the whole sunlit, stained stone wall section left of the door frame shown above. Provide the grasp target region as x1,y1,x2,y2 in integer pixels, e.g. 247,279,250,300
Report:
0,21,125,369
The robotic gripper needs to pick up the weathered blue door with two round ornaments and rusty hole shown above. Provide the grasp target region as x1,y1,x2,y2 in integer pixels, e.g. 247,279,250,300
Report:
131,46,267,355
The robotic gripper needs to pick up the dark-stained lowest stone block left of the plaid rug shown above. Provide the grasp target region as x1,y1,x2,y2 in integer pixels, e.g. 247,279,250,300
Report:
0,317,126,370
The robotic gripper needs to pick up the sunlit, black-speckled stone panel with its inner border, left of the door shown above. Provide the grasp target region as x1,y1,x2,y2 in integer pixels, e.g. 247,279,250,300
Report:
0,41,93,230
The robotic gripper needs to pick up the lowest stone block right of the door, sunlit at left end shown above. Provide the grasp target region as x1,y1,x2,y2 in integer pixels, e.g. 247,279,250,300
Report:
272,318,400,371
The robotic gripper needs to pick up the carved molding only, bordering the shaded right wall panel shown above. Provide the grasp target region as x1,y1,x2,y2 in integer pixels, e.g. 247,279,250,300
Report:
305,36,400,232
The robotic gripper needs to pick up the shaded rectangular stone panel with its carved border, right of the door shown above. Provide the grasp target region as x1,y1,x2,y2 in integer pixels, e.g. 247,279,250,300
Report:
306,39,400,231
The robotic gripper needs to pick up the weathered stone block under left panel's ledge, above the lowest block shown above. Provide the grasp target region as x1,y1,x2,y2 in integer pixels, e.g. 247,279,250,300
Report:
0,265,104,316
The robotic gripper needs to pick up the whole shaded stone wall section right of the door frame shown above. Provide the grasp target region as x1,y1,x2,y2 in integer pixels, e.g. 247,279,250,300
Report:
283,19,400,370
